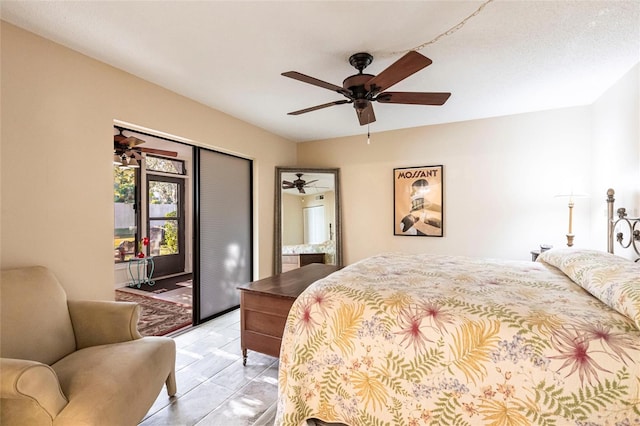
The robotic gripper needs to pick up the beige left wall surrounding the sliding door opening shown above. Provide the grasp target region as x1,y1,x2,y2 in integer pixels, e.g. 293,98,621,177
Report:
1,22,296,300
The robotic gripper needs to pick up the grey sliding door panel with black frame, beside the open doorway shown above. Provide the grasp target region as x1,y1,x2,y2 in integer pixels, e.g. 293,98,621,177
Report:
194,148,253,323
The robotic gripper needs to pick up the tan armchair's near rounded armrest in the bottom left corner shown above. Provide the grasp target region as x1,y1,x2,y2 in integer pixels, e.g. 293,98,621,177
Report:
0,358,69,420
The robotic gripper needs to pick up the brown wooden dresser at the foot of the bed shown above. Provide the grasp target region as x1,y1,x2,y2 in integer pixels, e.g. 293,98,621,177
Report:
238,263,340,365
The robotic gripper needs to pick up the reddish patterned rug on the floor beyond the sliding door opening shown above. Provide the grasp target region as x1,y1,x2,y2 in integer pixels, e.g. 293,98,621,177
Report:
116,289,192,336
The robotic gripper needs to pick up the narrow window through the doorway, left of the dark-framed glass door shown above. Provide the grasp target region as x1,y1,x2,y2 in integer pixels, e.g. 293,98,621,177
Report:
113,165,139,263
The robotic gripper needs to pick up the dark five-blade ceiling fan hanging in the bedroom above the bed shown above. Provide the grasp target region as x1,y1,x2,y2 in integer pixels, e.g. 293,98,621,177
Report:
282,50,451,126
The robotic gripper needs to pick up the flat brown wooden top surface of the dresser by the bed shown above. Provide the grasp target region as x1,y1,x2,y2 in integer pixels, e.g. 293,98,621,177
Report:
238,263,340,299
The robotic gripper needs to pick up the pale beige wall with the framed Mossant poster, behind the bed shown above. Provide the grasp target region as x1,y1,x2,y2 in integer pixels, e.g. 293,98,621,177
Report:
298,66,640,264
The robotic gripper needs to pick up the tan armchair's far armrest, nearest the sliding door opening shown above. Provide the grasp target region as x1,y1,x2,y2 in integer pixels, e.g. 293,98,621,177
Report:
67,300,142,349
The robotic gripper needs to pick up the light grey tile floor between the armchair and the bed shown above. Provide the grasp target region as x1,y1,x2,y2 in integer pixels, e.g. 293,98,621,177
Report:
140,310,278,426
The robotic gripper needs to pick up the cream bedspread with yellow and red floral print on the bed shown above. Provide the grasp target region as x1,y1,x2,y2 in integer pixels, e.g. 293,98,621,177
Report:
275,250,640,426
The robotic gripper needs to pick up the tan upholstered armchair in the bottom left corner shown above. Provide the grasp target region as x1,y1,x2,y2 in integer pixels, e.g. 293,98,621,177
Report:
0,266,176,426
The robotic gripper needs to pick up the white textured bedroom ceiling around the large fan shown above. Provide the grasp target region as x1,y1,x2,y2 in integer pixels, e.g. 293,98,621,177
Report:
0,0,640,142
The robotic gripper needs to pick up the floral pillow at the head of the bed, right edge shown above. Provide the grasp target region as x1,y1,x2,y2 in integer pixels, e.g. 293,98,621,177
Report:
537,249,640,330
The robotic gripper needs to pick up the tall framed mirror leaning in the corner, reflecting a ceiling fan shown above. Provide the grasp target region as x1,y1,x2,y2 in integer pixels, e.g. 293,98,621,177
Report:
273,167,342,274
